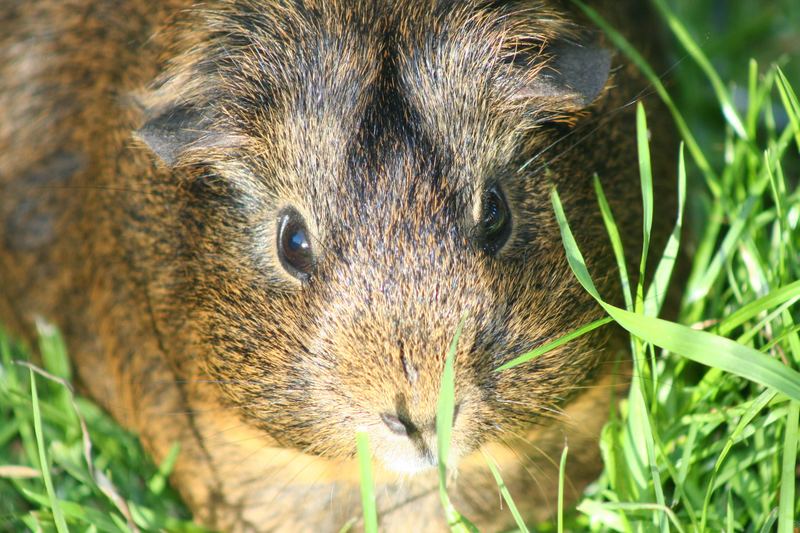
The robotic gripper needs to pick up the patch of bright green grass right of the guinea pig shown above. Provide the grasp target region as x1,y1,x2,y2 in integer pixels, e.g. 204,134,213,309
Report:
556,0,800,533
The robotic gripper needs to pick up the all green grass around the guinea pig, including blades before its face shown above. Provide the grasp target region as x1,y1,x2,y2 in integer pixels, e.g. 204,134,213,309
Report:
0,0,800,533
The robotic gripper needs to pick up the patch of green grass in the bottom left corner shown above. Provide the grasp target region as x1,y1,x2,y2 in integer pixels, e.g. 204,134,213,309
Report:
0,327,209,533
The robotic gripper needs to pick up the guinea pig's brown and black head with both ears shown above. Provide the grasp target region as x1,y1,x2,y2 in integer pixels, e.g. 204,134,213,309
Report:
138,1,608,473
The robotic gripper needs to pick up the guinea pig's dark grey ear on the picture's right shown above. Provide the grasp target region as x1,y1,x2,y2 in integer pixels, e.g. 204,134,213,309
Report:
516,36,611,112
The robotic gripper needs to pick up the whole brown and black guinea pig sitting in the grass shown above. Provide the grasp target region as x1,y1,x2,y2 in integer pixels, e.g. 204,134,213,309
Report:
0,0,668,531
